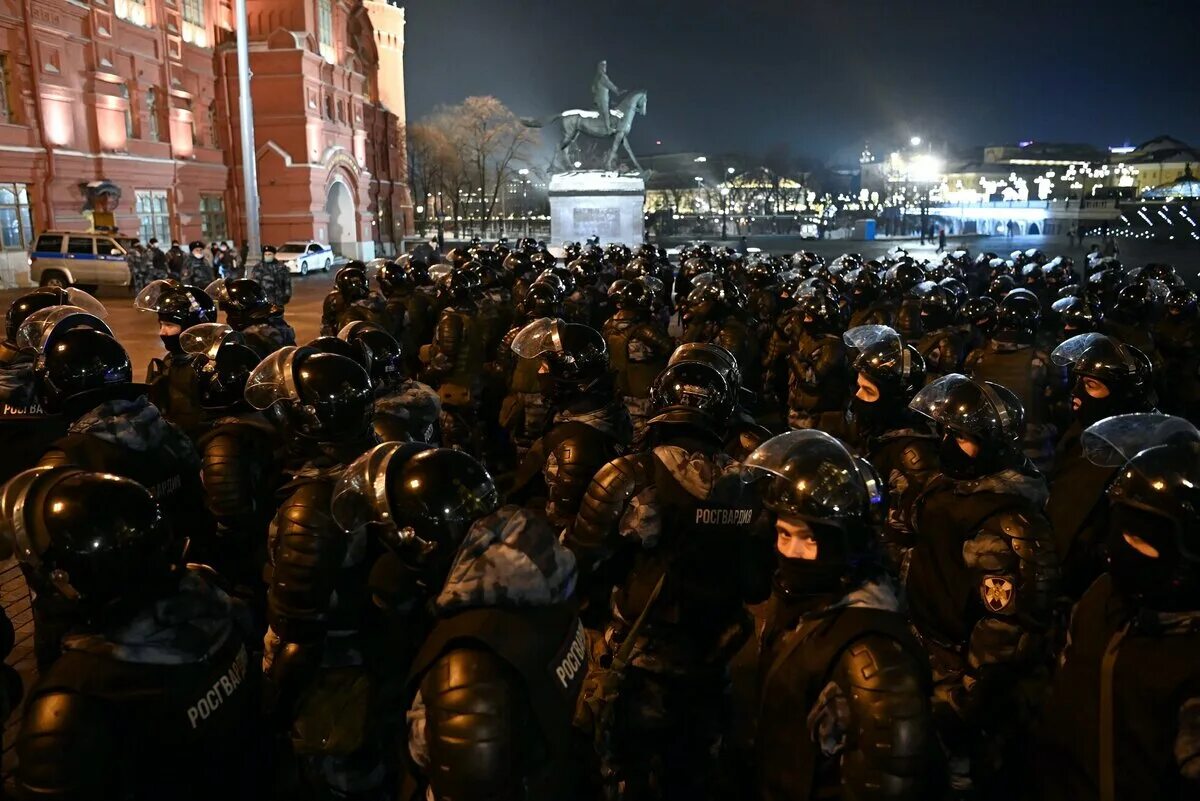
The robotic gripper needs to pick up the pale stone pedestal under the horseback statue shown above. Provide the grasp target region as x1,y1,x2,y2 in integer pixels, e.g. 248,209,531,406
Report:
550,170,646,247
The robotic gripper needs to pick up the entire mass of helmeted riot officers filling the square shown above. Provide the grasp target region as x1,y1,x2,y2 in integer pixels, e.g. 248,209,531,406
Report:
0,240,1200,801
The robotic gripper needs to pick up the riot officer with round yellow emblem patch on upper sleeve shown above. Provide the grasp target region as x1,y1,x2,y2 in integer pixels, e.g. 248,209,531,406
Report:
905,373,1058,794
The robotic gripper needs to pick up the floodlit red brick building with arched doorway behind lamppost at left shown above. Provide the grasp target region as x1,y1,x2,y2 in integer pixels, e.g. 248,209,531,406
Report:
0,0,412,285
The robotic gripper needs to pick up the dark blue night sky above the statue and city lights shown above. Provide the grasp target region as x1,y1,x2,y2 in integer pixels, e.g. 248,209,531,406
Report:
404,0,1200,163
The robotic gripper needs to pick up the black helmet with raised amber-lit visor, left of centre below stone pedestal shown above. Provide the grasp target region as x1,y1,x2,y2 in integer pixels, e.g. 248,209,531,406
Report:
512,318,608,403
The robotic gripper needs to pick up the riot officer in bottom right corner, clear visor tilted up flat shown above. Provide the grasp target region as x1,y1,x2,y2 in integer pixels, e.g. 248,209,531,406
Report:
1031,415,1200,801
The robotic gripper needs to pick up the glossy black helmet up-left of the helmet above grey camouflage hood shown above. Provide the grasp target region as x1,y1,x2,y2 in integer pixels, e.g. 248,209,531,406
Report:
246,345,374,442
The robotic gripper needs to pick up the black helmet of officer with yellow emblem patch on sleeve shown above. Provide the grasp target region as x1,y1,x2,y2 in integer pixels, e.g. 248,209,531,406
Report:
908,373,1025,480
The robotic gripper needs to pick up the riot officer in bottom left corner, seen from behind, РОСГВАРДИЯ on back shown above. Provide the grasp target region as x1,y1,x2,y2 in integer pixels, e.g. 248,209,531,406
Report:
0,468,263,800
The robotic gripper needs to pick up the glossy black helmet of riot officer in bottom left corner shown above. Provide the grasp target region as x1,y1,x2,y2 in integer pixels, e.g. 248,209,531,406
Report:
0,466,181,622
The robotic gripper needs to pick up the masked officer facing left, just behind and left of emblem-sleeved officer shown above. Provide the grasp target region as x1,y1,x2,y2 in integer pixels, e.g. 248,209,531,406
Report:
844,325,937,570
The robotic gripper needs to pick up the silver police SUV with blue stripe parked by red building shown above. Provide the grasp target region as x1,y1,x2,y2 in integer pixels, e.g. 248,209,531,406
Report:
29,231,137,291
